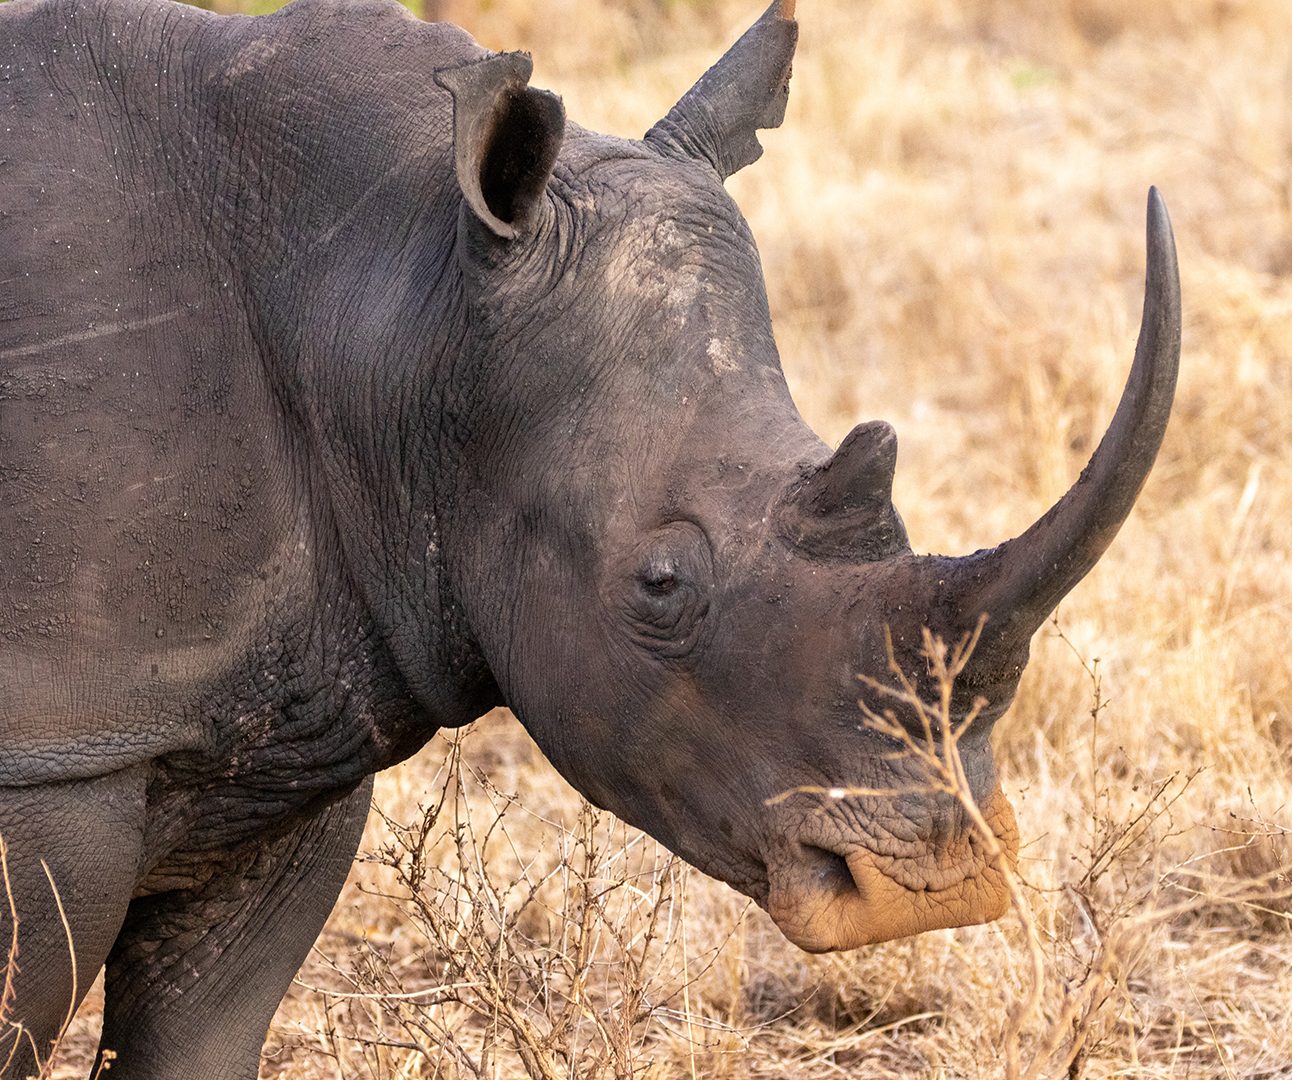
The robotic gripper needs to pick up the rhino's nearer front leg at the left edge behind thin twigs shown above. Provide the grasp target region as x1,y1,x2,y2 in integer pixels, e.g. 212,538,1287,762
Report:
0,769,143,1077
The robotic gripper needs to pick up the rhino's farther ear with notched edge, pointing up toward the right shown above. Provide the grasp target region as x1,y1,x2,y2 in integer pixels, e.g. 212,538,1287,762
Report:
646,0,798,180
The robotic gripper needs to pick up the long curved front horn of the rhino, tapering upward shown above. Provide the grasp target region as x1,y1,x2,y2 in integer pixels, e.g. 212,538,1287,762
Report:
956,187,1180,643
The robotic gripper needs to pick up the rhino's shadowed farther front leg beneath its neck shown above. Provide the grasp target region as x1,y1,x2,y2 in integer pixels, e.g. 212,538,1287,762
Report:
101,779,372,1080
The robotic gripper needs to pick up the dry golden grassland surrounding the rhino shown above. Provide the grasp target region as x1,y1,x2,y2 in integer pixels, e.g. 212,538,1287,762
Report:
45,0,1292,1080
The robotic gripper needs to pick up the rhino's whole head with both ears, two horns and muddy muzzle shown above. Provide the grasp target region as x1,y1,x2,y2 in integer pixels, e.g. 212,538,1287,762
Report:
437,0,1180,951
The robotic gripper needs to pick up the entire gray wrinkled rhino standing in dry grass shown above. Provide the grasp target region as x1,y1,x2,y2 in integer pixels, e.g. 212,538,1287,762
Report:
0,0,1180,1080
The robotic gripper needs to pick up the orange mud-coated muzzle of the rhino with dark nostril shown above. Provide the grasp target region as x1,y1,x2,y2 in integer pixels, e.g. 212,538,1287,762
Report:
760,788,1018,952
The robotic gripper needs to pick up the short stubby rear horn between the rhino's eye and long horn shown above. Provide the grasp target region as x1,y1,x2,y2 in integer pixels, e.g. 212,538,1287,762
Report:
780,420,910,561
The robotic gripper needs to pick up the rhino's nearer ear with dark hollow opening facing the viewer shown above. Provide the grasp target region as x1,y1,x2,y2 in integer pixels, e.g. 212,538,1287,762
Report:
435,53,565,240
